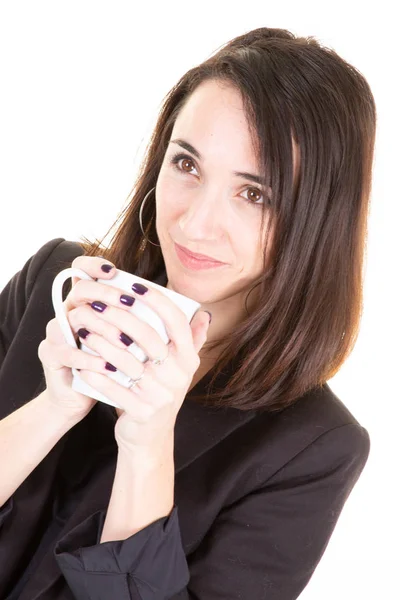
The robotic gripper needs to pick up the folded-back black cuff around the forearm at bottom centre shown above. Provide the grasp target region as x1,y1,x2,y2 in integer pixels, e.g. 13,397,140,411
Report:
54,506,189,600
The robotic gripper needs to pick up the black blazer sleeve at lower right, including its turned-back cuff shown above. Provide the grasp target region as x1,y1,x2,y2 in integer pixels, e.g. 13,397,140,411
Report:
55,424,370,600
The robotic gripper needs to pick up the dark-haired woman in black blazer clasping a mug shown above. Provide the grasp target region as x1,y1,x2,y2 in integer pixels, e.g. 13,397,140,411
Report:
0,28,376,600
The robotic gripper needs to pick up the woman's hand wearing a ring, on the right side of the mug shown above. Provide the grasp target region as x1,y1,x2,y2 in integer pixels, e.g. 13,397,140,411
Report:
70,282,209,454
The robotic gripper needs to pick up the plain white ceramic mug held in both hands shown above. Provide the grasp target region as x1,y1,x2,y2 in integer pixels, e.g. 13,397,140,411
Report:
52,267,201,408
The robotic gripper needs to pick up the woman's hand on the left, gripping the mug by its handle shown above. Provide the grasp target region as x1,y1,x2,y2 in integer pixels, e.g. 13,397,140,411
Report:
38,256,116,422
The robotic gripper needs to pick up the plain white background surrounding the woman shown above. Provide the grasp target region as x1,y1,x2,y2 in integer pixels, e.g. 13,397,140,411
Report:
0,0,400,600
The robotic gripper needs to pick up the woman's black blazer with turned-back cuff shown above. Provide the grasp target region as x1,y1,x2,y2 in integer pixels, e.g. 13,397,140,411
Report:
0,238,370,600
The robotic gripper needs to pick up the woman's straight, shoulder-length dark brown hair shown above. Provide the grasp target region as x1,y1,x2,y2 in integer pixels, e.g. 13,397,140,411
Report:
77,27,376,412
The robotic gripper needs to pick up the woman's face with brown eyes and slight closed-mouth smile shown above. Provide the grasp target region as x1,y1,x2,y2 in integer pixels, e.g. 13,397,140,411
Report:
156,81,294,304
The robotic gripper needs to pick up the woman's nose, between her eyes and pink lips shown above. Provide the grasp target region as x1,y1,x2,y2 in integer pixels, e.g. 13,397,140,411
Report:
179,189,227,240
